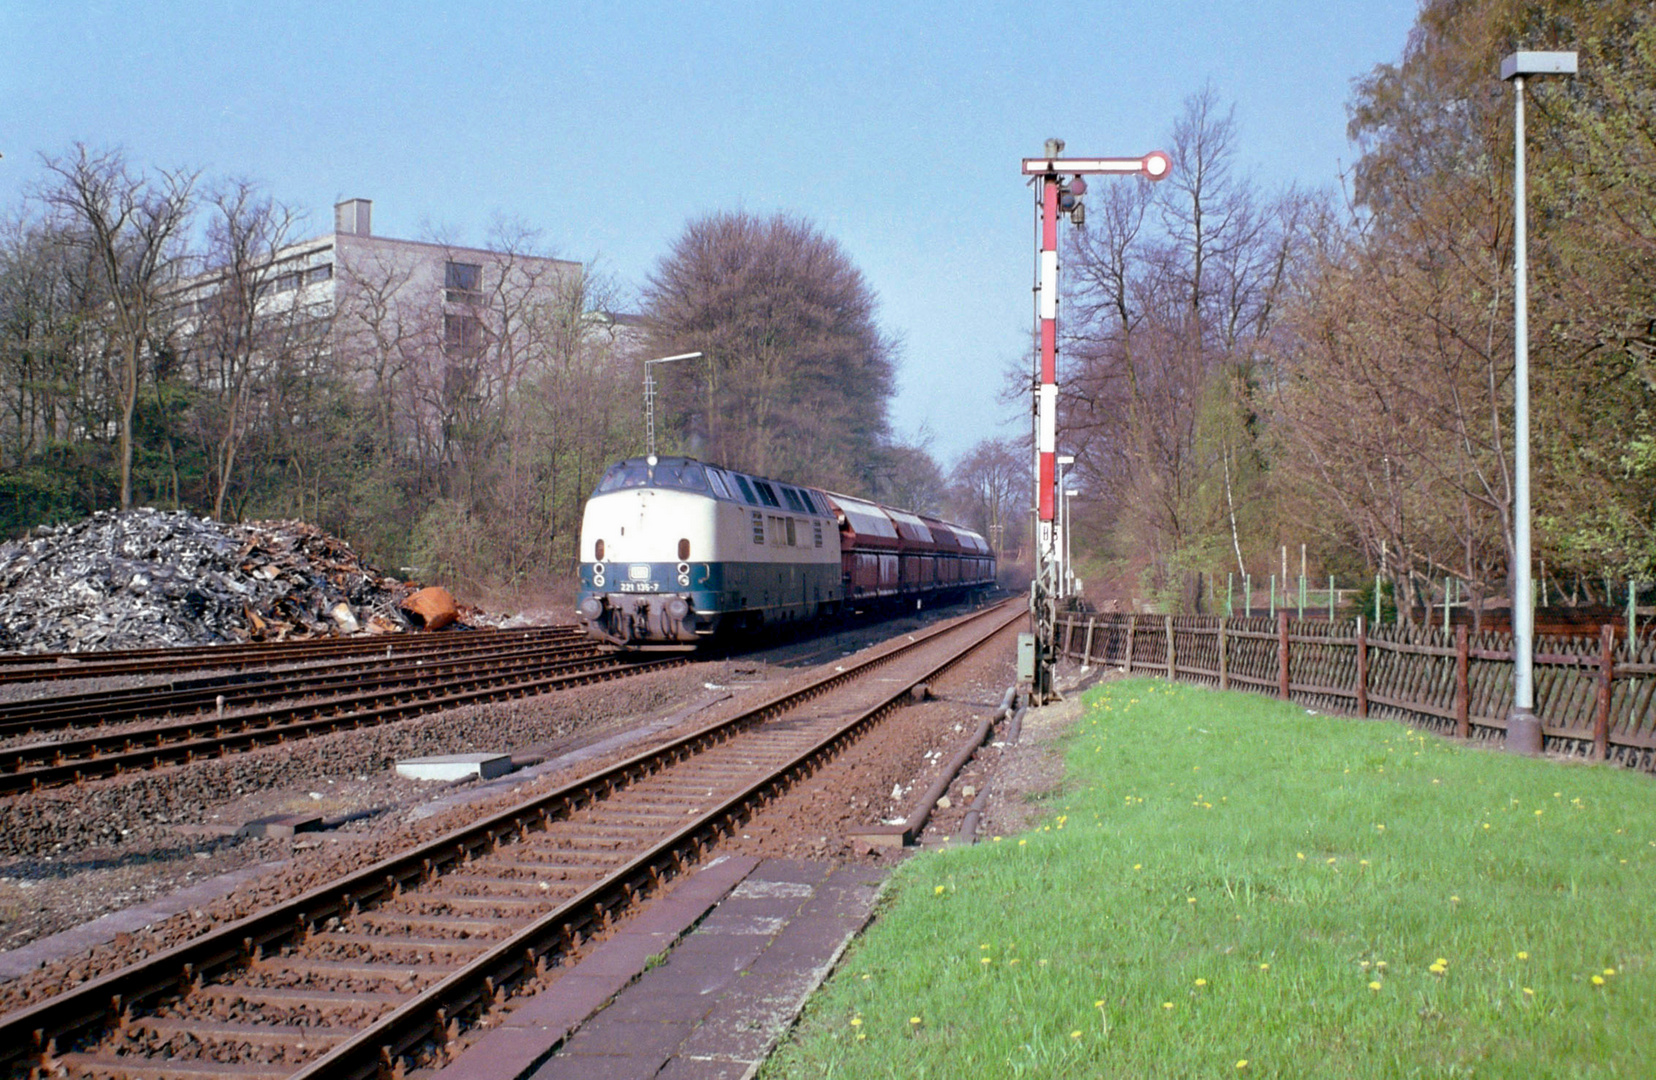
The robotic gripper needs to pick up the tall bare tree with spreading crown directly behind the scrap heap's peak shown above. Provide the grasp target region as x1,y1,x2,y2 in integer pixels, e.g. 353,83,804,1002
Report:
41,144,197,509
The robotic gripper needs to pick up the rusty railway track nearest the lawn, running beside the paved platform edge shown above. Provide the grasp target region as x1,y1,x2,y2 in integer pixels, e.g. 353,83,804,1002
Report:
0,603,1022,1080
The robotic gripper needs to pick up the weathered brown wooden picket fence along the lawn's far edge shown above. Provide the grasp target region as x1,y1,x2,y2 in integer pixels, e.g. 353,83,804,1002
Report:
1058,613,1656,772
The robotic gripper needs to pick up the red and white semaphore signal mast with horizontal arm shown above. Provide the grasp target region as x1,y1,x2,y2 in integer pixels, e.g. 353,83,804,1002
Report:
1023,139,1172,704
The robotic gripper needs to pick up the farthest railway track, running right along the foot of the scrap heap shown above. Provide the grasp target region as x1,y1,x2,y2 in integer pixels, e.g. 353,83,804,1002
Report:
0,626,580,682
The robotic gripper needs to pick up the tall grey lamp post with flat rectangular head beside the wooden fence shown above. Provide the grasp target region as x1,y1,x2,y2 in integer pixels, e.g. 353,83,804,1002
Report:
1500,53,1575,754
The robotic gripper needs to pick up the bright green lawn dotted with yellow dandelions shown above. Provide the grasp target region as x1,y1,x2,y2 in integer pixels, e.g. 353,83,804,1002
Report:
763,679,1656,1080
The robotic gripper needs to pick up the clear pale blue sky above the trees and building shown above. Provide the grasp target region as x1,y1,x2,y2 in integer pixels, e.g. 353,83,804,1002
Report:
0,0,1416,465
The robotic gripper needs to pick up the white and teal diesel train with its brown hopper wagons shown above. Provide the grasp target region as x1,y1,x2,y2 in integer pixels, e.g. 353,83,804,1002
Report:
576,456,995,649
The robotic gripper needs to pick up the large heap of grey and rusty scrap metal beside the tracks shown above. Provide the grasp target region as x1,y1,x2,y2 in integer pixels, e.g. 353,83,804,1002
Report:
0,509,419,653
